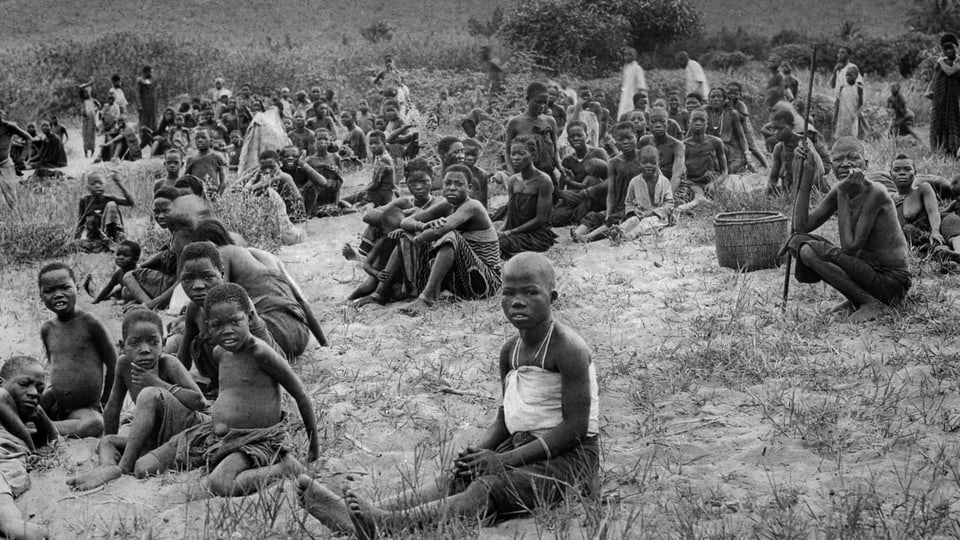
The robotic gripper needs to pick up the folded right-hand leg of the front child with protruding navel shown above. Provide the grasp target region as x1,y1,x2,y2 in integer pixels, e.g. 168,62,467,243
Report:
201,452,307,497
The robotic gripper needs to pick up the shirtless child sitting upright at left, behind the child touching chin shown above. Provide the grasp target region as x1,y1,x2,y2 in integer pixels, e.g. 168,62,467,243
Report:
38,263,117,437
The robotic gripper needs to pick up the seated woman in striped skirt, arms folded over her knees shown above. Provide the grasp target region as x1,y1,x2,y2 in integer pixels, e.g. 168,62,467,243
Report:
354,165,500,315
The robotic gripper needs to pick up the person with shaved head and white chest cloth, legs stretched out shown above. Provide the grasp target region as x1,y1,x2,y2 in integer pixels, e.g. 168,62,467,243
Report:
297,253,600,539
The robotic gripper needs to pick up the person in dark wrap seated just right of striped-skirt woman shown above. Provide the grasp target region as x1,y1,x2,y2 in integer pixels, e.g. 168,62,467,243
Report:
497,135,557,259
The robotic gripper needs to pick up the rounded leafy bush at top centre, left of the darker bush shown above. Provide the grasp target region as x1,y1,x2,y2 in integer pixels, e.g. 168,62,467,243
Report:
498,0,630,76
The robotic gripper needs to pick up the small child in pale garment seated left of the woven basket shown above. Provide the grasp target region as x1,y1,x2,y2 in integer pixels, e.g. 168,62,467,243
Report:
619,146,674,240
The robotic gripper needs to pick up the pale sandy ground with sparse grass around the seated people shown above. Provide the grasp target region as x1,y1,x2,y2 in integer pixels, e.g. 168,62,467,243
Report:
0,129,960,538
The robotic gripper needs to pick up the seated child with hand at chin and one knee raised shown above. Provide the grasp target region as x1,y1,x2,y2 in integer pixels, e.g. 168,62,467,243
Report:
67,308,208,491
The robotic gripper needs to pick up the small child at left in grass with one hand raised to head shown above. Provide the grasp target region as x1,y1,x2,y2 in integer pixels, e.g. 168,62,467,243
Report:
74,171,133,242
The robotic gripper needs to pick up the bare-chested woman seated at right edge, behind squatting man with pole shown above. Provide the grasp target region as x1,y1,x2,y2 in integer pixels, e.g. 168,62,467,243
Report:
890,154,960,262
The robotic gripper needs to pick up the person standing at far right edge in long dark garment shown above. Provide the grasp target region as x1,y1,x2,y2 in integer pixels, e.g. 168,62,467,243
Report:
927,33,960,157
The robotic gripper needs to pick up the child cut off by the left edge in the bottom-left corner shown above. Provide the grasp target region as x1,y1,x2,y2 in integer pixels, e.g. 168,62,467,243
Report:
0,356,57,539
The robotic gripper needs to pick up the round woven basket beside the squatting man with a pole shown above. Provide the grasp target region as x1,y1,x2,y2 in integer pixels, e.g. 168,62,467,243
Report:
713,212,788,272
